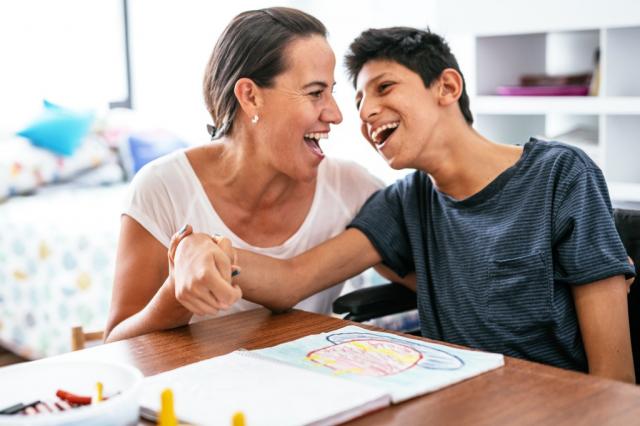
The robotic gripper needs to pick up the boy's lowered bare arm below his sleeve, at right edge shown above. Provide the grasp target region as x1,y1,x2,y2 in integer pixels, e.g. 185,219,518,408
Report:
572,275,635,383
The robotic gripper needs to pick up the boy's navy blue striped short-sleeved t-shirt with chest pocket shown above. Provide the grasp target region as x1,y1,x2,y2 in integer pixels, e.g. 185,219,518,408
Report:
349,138,634,371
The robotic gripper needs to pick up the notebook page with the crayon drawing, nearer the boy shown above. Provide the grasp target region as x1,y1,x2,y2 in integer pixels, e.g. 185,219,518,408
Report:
251,325,504,403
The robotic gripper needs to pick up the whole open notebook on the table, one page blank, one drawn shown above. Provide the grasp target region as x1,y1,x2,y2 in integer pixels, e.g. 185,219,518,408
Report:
140,326,504,426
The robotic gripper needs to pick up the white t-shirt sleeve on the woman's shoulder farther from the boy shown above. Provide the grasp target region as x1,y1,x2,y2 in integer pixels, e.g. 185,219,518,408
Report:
122,164,175,247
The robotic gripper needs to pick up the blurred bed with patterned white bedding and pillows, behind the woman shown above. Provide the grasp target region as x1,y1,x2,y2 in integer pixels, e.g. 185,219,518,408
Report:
0,105,186,359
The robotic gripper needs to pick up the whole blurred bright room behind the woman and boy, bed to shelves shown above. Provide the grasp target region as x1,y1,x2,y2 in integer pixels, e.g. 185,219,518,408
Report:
0,0,640,358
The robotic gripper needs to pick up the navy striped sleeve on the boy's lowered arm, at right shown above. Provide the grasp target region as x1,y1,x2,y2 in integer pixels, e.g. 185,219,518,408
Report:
553,168,635,285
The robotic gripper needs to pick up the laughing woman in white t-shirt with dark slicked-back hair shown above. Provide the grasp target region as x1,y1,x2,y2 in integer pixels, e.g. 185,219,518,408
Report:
106,8,382,341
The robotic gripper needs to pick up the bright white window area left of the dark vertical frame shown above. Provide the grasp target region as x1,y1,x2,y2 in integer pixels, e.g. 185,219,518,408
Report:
0,0,126,136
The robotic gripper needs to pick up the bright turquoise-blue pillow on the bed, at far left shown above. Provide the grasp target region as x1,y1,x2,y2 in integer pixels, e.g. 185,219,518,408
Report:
17,100,94,156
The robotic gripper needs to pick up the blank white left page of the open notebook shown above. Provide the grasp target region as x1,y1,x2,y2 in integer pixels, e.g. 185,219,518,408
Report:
140,352,390,426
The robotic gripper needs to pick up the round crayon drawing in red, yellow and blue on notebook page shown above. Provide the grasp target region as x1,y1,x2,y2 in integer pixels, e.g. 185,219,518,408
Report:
306,333,464,377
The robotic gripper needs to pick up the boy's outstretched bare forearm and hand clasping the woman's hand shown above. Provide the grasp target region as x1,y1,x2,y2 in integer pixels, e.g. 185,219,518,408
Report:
170,229,382,311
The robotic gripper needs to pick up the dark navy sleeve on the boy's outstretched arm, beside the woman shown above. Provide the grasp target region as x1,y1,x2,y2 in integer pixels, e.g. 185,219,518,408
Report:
348,183,414,277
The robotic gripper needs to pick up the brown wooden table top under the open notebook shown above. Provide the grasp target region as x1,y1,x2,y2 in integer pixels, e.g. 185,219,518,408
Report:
59,309,640,426
